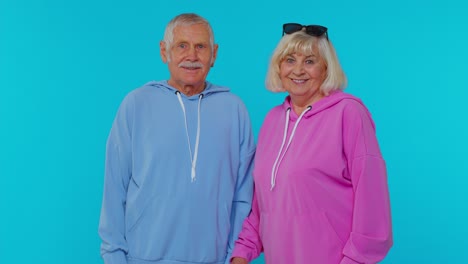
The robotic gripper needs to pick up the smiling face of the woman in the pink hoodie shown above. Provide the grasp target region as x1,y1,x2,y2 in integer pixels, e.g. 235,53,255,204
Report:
280,49,327,105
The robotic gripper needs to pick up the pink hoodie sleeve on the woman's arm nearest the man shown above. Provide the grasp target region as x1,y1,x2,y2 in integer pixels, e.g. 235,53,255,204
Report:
232,190,263,262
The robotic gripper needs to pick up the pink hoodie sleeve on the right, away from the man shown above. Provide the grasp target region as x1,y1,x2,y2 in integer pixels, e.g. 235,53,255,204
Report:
341,101,393,264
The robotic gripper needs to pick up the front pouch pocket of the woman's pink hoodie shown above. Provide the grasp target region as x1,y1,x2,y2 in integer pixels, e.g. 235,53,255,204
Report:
260,211,344,263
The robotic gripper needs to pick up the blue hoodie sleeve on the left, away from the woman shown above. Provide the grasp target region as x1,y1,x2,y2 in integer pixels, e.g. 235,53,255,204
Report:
99,93,133,264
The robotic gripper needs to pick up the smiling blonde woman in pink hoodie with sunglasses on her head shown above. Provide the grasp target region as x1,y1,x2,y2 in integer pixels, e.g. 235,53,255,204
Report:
232,24,393,264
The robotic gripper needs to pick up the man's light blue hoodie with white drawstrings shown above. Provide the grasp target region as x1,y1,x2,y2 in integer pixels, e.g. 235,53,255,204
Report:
99,81,255,264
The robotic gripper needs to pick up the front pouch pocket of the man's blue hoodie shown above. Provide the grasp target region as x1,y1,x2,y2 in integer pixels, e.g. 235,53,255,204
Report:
126,195,230,263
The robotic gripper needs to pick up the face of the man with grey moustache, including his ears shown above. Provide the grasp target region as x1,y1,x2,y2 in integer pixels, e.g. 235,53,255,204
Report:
160,24,218,92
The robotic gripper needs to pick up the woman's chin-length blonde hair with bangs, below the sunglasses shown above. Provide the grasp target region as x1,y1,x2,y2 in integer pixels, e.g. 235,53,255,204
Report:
265,31,347,94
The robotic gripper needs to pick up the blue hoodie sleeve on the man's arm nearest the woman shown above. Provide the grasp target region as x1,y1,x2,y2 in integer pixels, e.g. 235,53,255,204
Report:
225,104,255,263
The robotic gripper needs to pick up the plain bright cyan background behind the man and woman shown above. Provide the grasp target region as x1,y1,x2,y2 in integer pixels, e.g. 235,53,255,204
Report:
0,0,468,264
